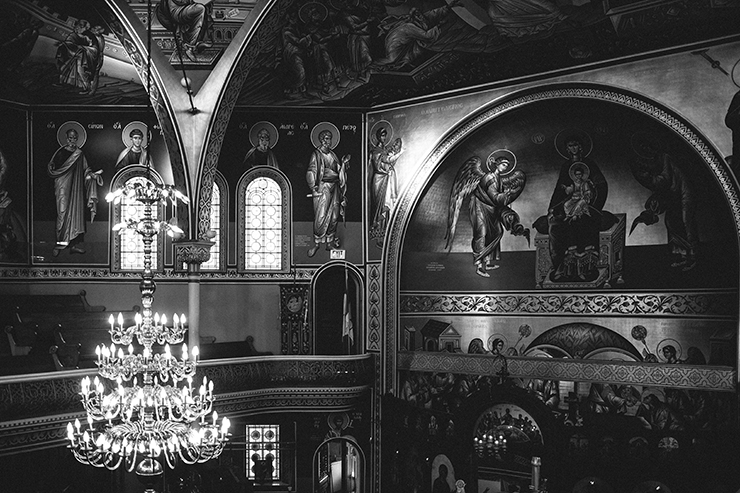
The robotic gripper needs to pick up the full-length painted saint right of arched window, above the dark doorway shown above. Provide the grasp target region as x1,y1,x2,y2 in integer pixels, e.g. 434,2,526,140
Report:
306,124,350,257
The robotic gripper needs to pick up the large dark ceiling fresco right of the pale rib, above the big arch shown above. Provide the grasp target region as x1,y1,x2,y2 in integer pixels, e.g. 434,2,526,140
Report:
239,0,740,107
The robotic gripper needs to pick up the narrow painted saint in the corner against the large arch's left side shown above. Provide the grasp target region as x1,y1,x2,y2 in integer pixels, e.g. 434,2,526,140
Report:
370,121,403,248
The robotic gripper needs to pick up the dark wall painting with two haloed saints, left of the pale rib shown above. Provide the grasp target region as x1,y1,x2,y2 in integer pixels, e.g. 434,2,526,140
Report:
31,111,172,264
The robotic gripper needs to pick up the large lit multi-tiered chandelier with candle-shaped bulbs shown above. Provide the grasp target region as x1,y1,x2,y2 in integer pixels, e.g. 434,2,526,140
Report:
67,180,229,477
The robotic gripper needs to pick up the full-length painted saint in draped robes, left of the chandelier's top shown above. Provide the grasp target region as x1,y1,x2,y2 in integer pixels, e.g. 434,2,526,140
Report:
47,124,103,257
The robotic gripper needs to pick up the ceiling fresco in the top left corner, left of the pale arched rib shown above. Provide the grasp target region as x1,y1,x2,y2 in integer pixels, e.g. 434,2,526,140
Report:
0,0,146,105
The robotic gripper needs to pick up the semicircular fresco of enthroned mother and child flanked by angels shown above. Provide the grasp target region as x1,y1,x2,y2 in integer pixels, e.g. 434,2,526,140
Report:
401,99,737,291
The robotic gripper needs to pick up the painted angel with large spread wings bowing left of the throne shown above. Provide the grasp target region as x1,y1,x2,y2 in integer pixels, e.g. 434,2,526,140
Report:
445,149,529,277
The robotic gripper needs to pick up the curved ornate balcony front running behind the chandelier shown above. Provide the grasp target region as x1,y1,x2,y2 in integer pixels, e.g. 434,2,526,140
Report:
0,354,375,456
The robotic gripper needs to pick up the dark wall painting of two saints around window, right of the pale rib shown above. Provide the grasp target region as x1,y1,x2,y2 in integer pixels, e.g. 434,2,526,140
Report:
218,108,364,264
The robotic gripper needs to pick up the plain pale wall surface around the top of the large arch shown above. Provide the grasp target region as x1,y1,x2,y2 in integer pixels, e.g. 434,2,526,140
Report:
367,39,740,259
